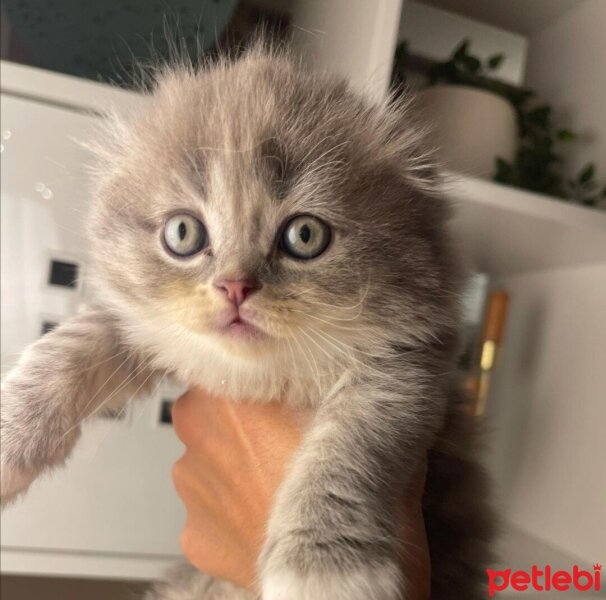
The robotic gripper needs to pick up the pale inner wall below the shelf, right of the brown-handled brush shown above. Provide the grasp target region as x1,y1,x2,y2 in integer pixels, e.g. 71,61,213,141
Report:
488,264,606,564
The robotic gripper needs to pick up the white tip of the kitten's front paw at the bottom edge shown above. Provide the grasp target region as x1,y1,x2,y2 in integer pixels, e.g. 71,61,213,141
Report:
262,563,403,600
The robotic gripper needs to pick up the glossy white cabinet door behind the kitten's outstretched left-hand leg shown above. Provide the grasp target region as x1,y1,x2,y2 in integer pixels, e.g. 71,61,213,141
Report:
1,95,184,577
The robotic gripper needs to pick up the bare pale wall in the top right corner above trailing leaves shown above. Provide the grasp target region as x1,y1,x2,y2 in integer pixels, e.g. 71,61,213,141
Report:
526,0,606,181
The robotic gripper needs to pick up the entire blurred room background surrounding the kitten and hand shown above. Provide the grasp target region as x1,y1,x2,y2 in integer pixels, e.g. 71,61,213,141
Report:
0,0,606,600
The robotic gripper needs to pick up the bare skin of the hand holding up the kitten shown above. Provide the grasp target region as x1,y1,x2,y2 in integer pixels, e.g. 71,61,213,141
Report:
173,389,430,600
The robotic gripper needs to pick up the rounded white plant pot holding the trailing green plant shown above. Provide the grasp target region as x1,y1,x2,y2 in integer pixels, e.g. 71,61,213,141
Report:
415,85,518,179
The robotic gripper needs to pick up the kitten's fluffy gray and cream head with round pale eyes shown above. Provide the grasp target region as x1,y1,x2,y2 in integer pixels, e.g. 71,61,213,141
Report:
91,51,455,398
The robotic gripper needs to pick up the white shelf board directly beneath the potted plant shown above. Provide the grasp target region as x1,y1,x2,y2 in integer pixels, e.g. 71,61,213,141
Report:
446,173,606,277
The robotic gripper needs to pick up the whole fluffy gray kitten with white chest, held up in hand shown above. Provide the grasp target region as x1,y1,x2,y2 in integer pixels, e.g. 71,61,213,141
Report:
1,48,491,600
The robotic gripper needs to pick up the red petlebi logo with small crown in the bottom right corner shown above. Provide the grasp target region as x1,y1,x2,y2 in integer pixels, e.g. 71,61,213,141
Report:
486,563,602,598
